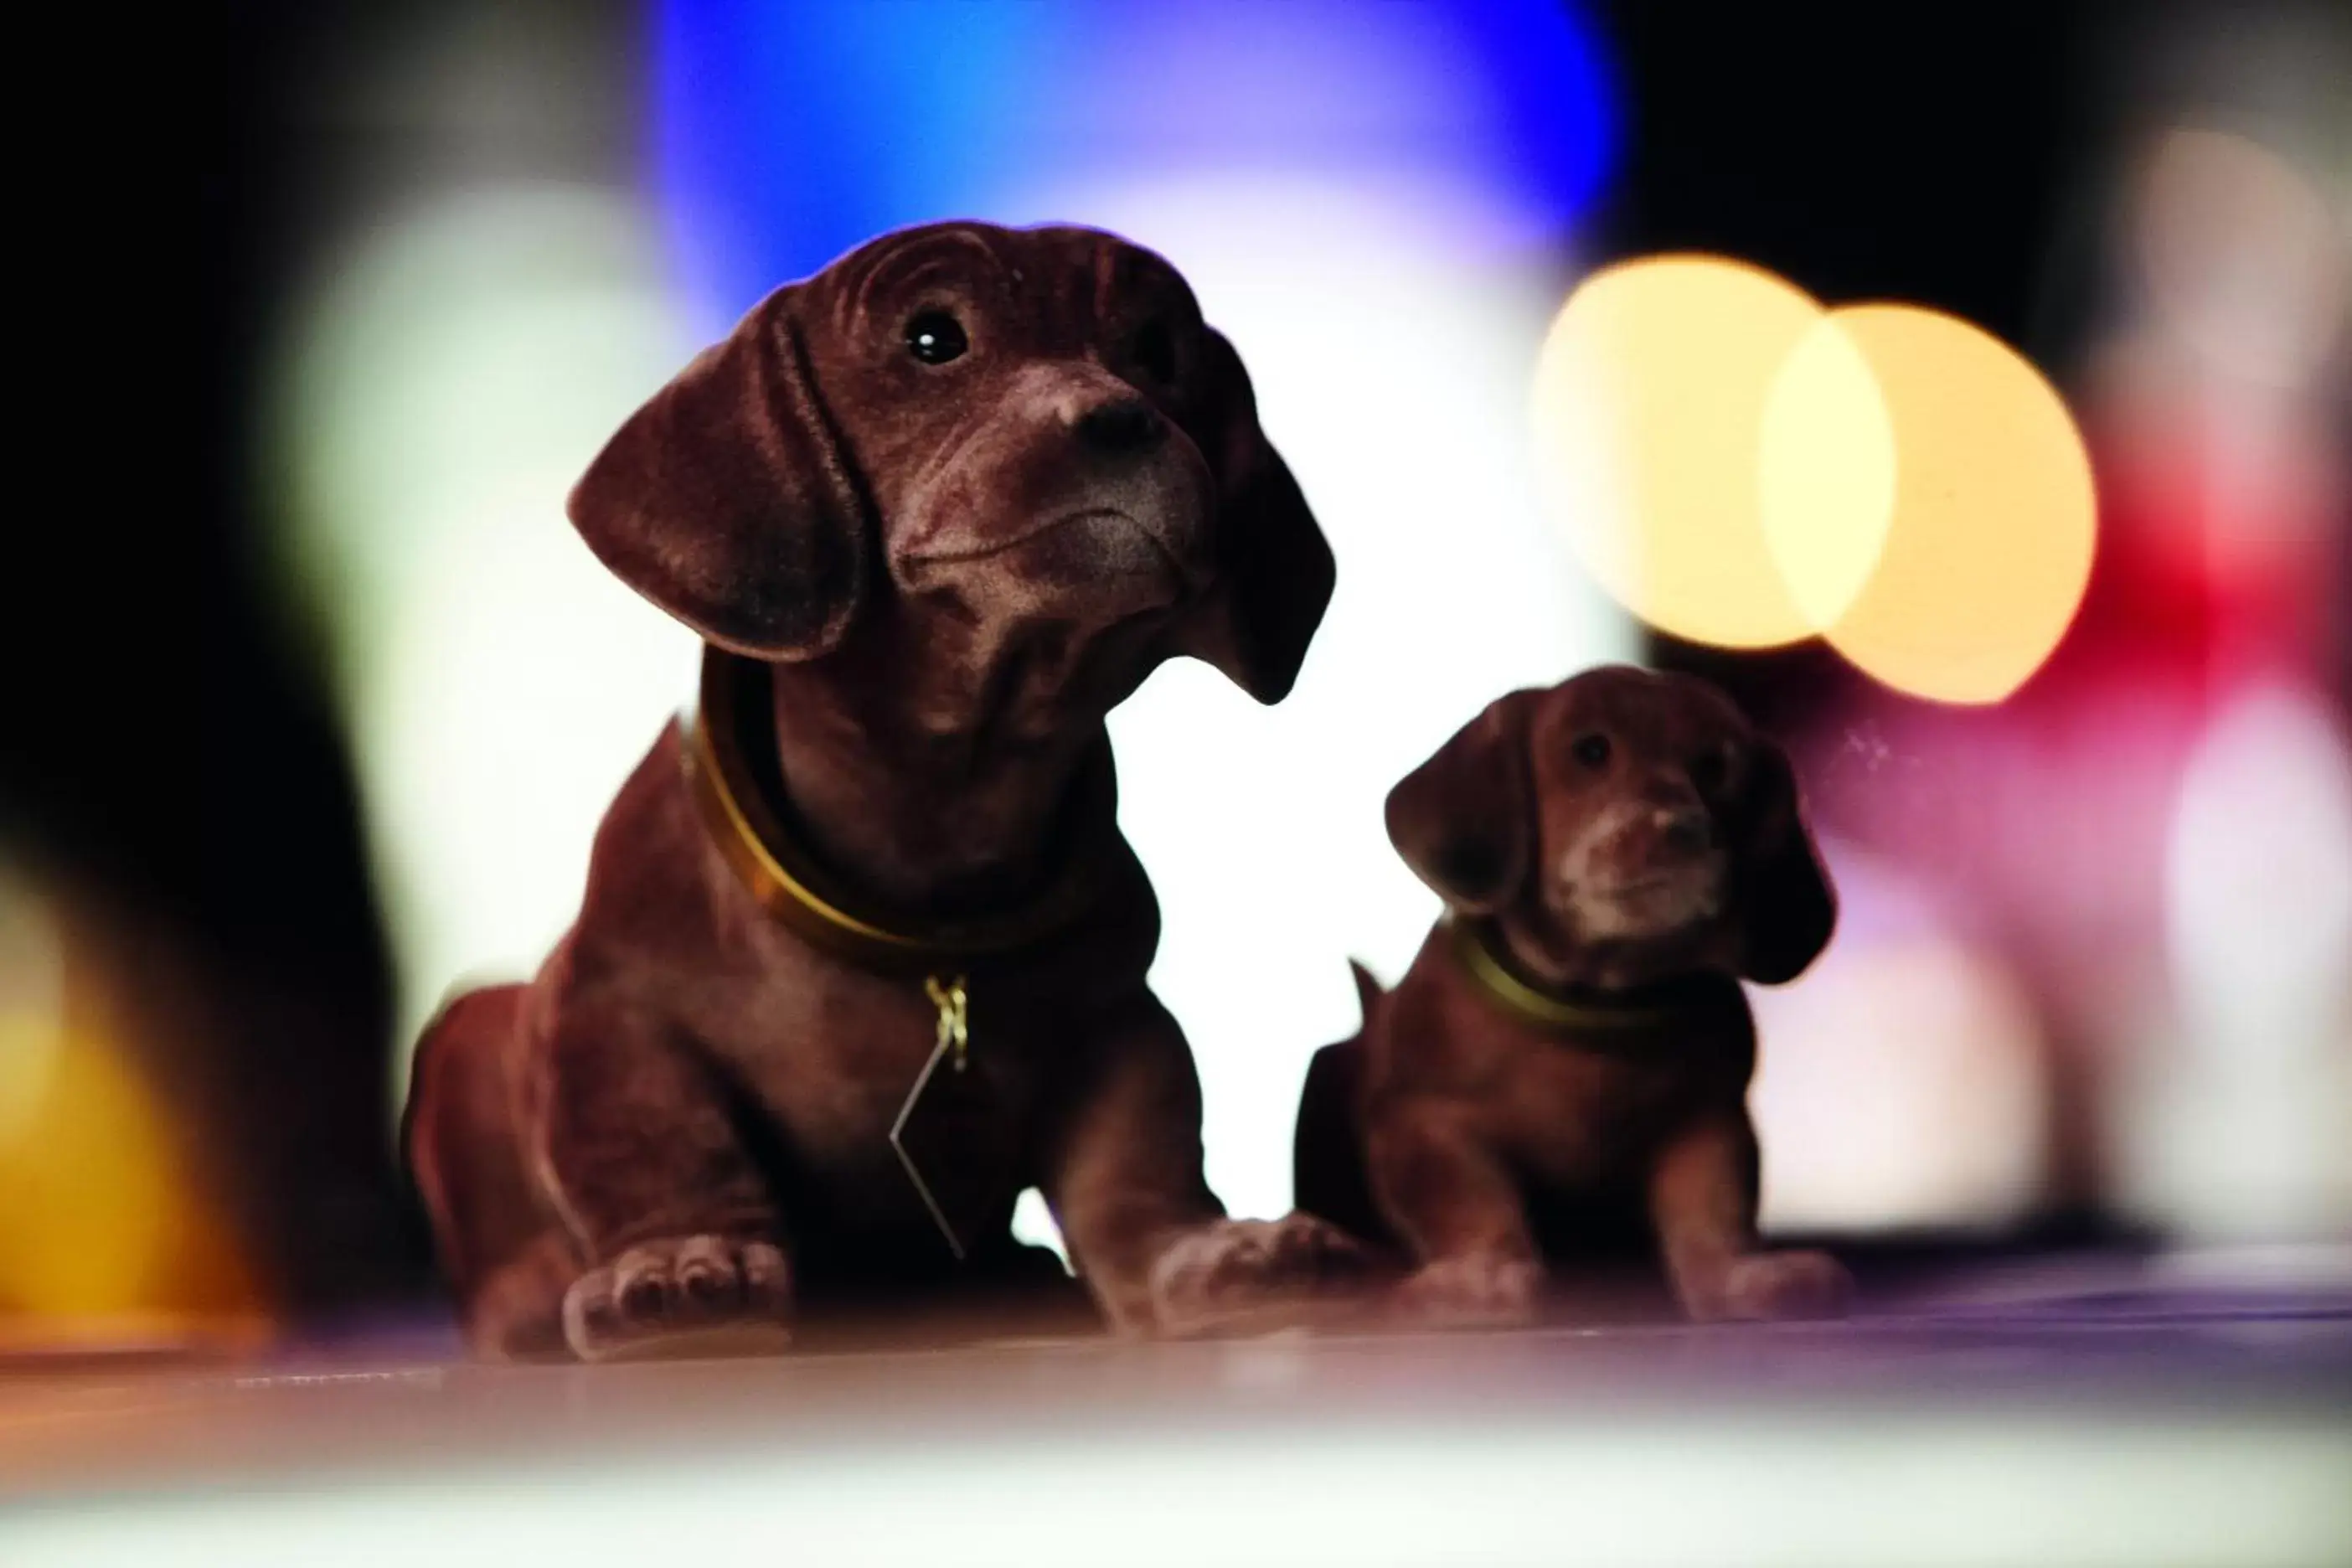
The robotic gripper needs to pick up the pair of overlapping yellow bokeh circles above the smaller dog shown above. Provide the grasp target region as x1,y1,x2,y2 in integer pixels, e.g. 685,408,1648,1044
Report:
1534,256,2096,703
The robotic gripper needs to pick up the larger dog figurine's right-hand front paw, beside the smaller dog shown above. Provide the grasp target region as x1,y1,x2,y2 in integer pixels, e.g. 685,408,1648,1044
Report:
1150,1213,1378,1335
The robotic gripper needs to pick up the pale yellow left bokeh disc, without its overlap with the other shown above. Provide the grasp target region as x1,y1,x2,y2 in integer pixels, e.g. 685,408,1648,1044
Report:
1534,256,1868,649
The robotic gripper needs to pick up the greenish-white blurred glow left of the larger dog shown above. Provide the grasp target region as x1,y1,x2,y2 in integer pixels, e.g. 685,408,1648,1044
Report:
280,186,699,1100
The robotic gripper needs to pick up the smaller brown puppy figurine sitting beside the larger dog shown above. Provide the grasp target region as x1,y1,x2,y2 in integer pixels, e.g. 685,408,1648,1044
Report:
1296,668,1846,1321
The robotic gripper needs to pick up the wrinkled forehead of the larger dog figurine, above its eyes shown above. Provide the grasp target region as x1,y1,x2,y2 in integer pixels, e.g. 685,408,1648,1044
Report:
809,224,1197,341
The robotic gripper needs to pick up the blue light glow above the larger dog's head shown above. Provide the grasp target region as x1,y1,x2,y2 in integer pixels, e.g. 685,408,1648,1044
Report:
654,0,1611,317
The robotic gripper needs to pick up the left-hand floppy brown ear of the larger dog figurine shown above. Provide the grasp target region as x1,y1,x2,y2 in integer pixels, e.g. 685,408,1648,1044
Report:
570,285,868,658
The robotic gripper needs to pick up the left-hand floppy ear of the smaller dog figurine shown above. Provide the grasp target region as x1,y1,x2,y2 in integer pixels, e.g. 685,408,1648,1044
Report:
1388,691,1536,915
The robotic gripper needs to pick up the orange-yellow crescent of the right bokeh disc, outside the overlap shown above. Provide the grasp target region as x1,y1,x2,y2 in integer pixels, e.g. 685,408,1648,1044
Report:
1797,306,2098,703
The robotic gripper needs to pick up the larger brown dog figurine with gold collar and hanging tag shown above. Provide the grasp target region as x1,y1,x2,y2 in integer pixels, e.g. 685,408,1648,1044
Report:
405,224,1357,1359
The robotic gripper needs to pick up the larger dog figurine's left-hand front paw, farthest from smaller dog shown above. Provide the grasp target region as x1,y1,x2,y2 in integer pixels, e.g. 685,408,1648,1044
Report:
565,1236,792,1361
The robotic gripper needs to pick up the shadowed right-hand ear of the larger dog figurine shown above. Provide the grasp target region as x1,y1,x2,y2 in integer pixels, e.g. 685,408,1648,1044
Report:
1188,327,1336,703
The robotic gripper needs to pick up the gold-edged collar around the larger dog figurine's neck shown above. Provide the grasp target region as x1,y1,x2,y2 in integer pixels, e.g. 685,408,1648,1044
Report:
684,647,1110,968
